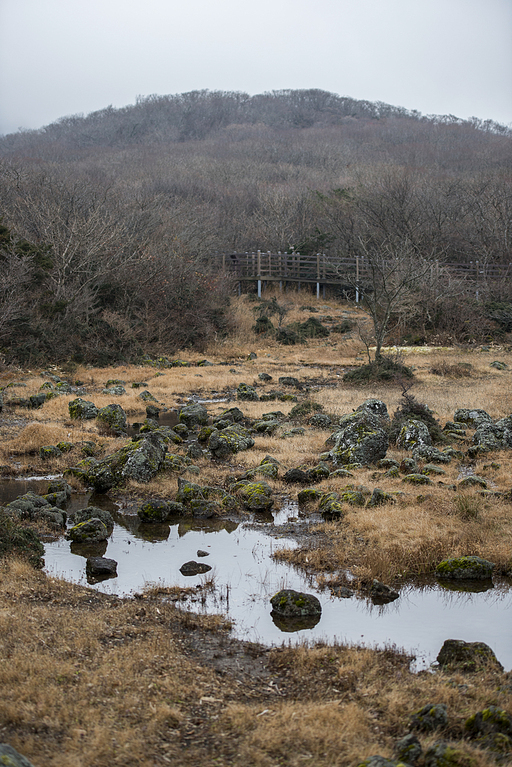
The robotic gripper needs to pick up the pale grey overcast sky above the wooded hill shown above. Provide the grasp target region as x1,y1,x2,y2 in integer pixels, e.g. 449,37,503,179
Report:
0,0,512,134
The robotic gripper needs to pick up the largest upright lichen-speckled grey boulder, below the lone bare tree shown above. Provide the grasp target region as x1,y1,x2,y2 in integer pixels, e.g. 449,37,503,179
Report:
329,409,389,466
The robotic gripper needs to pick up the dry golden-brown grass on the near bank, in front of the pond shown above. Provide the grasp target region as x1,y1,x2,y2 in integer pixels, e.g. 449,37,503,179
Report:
0,561,509,767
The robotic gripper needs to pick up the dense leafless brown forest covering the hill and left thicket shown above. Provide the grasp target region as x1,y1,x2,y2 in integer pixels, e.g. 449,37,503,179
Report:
0,90,512,363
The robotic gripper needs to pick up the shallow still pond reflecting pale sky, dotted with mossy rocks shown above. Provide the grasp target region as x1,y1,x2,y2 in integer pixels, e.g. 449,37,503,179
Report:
1,479,512,671
